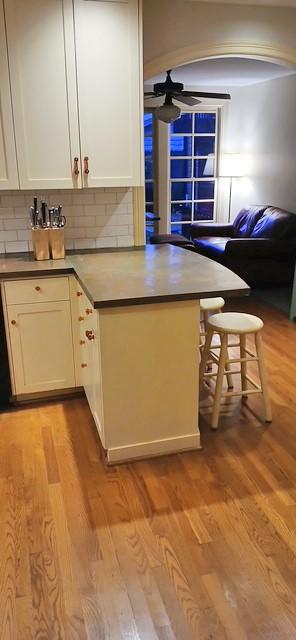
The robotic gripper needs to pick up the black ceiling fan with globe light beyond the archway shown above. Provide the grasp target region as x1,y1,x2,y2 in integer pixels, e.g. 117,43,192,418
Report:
144,69,230,124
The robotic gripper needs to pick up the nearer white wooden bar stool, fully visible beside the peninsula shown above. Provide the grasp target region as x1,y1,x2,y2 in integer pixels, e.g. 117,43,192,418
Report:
200,313,272,429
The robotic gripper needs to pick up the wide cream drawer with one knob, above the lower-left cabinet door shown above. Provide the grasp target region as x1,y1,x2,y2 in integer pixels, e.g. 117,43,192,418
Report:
4,277,70,305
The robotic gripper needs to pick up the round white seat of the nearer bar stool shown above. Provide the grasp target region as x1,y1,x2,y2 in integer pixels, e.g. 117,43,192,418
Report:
208,311,263,334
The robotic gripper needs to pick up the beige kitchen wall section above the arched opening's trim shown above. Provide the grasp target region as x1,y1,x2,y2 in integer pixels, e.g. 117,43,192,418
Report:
144,0,296,71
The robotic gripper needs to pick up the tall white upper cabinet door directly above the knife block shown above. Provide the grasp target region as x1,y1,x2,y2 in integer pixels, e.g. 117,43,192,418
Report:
4,0,81,189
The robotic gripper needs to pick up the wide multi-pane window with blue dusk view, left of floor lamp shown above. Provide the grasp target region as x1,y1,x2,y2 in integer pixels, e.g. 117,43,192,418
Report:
169,112,217,236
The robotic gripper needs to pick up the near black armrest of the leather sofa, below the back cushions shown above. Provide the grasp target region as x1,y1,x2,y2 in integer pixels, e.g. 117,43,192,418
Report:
225,238,296,259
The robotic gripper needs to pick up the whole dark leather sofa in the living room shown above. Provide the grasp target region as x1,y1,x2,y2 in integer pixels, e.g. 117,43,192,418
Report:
191,205,296,287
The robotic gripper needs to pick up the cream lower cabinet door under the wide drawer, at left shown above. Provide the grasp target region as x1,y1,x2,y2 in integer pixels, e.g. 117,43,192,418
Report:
7,301,75,395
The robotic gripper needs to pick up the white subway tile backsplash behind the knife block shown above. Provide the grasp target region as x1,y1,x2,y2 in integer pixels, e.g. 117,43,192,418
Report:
0,187,134,253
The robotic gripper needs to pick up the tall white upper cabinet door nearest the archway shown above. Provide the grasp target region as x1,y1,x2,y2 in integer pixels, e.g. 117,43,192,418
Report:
74,0,142,187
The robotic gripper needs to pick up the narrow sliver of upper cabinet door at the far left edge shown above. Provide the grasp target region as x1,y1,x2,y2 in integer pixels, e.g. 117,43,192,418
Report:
0,2,19,189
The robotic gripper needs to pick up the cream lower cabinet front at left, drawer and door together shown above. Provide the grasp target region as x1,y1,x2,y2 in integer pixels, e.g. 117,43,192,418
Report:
4,277,76,396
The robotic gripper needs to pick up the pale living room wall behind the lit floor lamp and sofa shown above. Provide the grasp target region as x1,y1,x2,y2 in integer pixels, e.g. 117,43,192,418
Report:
220,75,296,218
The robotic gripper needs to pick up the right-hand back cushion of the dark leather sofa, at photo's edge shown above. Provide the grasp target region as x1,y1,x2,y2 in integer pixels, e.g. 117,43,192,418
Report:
251,207,296,240
